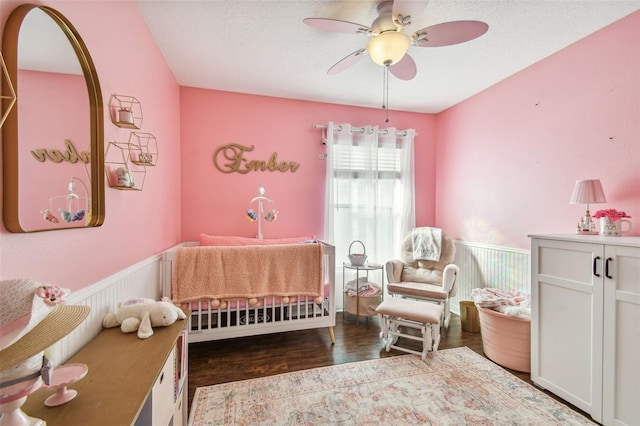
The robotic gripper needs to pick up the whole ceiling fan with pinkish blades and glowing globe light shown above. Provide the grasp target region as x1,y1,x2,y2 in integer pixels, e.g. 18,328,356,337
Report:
303,0,489,80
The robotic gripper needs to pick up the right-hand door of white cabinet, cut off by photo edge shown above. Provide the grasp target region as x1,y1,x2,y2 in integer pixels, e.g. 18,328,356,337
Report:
602,246,640,425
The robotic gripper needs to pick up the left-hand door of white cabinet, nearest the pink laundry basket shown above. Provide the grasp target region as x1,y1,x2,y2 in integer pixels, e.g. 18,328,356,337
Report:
531,238,604,421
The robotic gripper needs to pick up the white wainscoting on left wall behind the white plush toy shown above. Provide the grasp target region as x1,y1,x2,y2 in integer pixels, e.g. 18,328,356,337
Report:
47,254,162,365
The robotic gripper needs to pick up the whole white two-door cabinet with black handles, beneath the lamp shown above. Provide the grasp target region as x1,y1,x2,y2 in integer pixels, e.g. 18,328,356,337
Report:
531,235,640,425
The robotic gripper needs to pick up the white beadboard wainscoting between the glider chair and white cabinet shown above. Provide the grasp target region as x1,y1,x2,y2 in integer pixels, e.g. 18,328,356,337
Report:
451,241,531,314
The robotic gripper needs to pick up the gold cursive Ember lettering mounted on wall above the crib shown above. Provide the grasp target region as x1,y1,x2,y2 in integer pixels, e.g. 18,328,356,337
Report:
213,143,300,174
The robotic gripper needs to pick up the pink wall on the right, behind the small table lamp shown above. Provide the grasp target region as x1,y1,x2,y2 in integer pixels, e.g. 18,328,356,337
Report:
435,12,640,248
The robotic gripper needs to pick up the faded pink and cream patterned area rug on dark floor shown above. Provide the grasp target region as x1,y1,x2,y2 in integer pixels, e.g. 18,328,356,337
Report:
189,347,594,426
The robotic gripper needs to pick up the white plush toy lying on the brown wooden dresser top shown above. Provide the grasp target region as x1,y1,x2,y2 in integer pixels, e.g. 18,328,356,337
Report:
102,298,187,339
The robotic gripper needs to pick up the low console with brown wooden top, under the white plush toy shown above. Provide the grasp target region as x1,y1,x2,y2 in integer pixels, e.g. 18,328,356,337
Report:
22,312,190,426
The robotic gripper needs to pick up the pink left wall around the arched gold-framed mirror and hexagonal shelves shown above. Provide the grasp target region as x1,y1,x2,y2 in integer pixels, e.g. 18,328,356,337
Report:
0,0,180,290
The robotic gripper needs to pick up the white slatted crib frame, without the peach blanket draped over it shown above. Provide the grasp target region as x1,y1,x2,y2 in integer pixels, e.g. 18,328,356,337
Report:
162,242,335,343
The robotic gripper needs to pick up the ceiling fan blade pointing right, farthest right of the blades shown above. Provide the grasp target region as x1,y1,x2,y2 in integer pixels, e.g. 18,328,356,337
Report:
412,21,489,47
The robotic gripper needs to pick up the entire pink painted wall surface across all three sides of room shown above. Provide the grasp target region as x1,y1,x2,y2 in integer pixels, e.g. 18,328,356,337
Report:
0,0,640,290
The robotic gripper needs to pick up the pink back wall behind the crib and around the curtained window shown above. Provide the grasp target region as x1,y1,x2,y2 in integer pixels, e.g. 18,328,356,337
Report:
181,87,435,241
